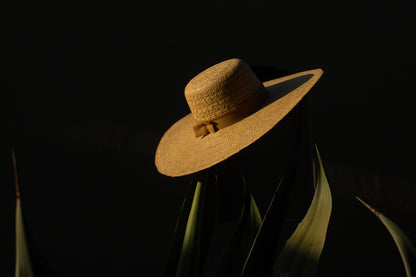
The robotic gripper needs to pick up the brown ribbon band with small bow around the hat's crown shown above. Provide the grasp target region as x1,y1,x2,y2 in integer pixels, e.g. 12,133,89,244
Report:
194,84,268,137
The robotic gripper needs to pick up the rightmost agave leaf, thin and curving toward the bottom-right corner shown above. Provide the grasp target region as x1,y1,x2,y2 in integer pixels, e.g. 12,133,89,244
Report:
356,197,416,277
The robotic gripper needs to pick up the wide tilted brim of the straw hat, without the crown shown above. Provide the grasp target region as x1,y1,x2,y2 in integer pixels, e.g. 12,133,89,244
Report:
155,69,323,177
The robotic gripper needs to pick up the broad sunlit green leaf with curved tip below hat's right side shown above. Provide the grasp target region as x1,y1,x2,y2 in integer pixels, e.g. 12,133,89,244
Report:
273,144,332,277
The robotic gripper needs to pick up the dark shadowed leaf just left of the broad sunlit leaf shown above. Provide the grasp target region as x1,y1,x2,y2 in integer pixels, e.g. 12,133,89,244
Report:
240,104,316,277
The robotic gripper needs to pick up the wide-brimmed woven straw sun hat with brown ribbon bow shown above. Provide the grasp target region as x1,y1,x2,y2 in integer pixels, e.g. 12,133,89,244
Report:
155,59,323,177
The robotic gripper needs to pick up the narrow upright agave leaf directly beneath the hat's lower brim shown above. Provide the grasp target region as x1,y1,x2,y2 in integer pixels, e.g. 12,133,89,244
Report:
163,171,217,277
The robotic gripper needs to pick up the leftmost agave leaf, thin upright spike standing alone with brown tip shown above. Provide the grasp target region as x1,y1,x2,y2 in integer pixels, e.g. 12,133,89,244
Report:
12,149,34,277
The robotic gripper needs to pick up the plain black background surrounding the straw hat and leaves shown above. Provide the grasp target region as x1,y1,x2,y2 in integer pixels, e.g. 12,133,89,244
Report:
0,0,416,276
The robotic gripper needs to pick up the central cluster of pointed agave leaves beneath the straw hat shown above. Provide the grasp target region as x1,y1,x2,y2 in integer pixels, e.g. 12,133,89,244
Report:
164,146,332,277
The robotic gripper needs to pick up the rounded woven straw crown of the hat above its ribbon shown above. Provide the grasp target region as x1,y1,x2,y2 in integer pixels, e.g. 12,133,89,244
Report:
185,59,262,122
